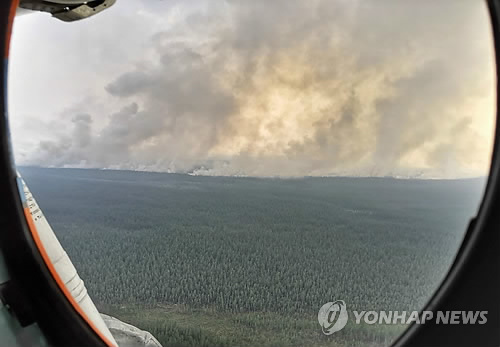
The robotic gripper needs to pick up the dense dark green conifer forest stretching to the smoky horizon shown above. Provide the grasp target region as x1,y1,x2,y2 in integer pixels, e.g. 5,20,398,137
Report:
20,168,484,347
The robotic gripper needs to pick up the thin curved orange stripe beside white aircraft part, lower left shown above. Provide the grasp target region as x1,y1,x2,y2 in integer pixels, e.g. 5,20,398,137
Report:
24,207,116,347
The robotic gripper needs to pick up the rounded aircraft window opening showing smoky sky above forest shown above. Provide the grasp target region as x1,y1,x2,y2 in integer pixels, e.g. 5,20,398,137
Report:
9,0,496,347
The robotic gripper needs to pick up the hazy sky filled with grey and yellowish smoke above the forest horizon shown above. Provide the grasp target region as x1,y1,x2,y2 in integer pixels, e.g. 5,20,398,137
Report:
9,0,495,178
